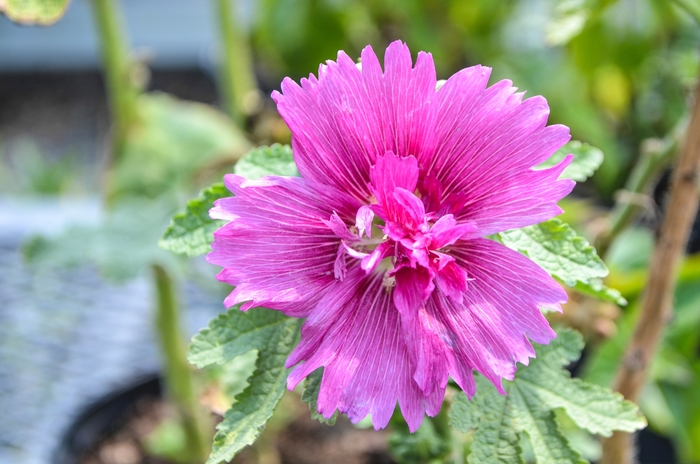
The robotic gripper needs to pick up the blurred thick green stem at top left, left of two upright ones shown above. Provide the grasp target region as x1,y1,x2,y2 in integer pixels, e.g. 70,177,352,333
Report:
92,0,139,160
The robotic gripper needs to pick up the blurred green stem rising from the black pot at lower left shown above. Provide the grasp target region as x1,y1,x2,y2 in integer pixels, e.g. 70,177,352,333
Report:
153,264,209,463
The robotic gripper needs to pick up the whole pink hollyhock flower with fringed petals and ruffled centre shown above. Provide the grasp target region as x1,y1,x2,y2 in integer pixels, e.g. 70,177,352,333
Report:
208,42,574,431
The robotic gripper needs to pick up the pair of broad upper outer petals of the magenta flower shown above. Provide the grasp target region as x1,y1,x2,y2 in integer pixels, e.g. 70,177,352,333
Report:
273,42,573,236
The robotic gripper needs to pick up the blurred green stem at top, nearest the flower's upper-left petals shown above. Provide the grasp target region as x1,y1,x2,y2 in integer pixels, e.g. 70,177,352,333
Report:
215,0,260,125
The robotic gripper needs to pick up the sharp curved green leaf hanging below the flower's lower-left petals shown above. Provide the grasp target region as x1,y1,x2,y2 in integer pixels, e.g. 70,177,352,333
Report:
188,306,301,464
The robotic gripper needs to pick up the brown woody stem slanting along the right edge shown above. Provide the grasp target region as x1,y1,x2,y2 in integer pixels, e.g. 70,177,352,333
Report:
601,84,700,464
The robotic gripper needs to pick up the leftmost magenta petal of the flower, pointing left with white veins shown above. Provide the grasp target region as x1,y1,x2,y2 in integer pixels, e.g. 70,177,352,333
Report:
207,174,360,317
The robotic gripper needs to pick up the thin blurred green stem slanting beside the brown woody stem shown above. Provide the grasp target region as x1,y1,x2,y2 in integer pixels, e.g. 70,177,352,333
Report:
596,120,687,256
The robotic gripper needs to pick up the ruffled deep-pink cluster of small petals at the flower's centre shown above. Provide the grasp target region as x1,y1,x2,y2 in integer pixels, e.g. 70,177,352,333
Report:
325,151,476,315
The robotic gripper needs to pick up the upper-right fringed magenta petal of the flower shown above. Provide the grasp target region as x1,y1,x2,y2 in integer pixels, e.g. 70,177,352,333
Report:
426,70,574,236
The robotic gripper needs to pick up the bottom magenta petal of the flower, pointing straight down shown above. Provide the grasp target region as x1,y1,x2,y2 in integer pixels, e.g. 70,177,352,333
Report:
287,267,444,431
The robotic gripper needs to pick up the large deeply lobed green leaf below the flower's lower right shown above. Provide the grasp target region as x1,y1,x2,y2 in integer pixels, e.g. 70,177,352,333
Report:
450,330,646,464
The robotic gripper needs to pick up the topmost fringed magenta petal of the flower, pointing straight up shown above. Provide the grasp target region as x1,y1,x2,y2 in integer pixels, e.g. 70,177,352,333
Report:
272,42,436,200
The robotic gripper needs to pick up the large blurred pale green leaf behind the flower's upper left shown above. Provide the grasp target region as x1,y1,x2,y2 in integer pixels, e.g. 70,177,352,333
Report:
112,93,250,201
